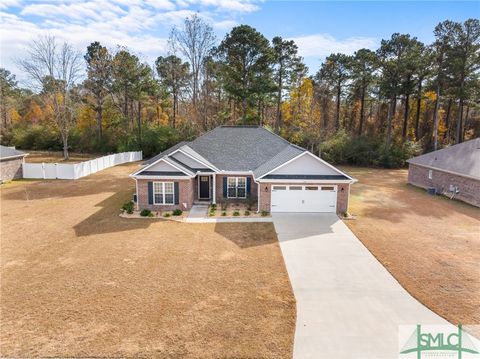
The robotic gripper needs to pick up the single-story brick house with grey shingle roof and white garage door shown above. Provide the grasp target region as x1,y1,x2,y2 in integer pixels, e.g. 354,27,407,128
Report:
131,126,355,213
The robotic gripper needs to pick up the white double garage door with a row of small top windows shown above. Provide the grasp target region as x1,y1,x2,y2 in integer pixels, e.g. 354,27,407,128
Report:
272,185,337,212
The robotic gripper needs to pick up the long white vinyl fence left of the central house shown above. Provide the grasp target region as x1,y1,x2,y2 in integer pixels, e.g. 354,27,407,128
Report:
22,151,143,179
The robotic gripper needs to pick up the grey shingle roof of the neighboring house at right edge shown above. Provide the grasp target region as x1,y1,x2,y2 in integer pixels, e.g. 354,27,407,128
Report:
407,137,480,179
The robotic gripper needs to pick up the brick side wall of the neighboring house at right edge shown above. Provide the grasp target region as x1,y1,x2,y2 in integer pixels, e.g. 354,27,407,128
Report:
408,164,480,207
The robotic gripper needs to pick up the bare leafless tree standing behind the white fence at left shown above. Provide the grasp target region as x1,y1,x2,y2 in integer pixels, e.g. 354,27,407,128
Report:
17,36,82,159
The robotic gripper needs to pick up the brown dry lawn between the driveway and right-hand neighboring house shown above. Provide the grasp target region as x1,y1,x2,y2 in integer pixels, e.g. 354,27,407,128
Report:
343,167,480,336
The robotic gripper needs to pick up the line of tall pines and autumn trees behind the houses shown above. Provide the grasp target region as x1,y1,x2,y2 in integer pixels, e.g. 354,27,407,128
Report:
0,15,480,166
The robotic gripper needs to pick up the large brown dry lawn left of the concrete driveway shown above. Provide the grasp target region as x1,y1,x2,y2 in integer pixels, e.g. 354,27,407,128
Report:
0,164,295,358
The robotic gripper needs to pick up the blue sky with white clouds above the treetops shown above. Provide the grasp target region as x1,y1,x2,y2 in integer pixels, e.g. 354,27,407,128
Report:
0,0,480,79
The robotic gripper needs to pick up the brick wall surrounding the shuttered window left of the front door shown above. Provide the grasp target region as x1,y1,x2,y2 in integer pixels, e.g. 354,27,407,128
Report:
137,179,196,211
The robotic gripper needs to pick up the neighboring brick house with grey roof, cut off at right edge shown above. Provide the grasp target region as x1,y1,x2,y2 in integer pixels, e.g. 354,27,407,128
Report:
407,138,480,207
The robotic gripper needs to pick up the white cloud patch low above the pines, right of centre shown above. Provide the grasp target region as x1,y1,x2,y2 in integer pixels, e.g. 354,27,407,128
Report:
290,34,378,58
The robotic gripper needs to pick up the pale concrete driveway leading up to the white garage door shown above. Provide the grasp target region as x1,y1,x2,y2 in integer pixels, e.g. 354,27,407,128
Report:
273,213,448,359
